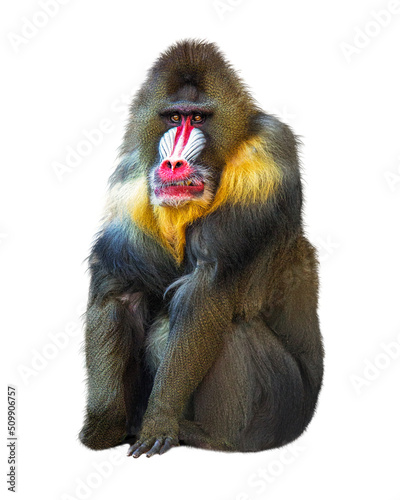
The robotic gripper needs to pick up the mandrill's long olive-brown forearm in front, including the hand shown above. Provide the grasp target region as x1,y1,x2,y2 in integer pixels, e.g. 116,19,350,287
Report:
128,264,233,458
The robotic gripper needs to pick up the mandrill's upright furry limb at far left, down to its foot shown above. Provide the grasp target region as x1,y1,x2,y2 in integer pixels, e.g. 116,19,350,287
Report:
79,294,148,450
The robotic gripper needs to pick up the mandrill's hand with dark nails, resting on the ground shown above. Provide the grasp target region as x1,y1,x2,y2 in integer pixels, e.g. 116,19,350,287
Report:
128,417,179,458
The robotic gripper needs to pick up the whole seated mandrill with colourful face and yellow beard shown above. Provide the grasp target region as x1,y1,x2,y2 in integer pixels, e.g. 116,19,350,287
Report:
80,40,323,457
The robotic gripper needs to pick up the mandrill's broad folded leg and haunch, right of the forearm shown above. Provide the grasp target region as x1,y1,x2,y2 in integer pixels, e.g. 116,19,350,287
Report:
179,318,315,452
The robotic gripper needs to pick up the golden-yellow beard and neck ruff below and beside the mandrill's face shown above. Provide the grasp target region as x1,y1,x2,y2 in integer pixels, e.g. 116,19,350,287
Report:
110,138,281,264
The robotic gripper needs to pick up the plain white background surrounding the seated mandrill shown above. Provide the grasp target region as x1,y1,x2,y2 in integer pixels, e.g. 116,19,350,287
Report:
0,0,400,500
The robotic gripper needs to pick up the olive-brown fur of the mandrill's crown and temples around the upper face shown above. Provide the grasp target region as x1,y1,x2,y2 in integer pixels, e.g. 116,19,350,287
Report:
122,40,260,156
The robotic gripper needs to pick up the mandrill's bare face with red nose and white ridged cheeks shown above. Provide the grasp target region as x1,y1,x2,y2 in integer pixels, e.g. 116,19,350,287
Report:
150,107,211,207
